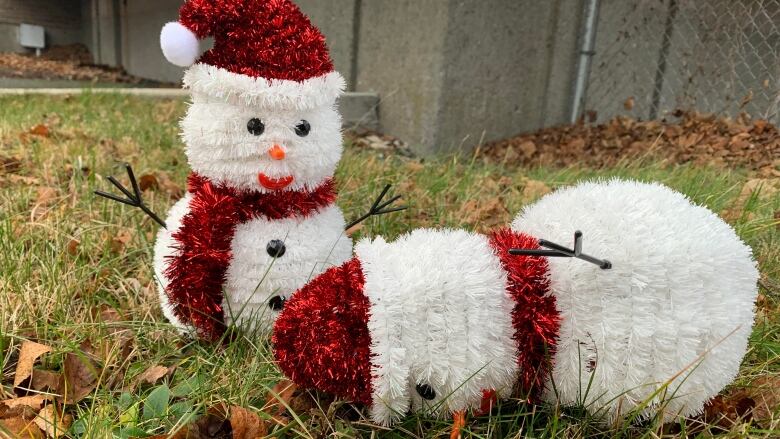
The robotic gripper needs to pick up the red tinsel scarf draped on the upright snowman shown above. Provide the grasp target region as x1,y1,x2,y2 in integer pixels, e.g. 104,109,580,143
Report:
165,174,336,340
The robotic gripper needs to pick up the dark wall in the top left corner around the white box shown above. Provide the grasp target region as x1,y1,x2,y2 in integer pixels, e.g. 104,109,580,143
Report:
0,0,82,52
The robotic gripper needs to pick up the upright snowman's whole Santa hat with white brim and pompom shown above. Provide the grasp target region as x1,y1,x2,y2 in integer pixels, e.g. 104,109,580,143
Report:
160,0,345,109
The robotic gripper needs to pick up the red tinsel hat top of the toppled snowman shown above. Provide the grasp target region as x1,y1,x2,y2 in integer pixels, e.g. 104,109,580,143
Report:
273,259,371,404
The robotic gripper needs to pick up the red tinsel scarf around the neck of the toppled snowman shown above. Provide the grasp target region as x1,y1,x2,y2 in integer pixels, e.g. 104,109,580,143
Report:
490,229,561,400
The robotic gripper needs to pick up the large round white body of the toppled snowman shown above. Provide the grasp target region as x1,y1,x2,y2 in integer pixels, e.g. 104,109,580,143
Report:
512,180,758,420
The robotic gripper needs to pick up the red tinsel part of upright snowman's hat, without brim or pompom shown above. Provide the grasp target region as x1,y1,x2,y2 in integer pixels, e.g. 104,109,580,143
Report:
179,0,333,82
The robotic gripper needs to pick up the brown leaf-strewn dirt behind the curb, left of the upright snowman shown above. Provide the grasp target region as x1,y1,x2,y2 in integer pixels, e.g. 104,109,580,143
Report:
0,44,174,86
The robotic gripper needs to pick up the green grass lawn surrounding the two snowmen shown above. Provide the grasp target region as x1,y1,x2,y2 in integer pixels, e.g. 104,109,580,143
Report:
0,95,780,438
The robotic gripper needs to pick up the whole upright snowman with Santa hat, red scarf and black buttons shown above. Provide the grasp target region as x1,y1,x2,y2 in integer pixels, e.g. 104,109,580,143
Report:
154,0,360,340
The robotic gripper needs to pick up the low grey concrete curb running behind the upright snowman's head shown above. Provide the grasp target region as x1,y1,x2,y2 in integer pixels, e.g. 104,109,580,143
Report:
0,88,379,131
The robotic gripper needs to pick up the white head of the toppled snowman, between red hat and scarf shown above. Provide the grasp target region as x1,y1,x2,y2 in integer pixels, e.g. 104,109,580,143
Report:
355,229,517,425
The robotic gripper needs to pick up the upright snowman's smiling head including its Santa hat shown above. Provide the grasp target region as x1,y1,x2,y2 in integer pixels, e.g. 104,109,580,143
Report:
160,0,345,192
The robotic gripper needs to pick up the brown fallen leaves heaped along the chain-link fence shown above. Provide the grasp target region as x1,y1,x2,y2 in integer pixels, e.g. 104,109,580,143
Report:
481,111,780,177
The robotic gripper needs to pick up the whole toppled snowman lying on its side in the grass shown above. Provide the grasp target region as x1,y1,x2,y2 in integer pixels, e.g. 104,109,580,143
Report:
273,180,758,425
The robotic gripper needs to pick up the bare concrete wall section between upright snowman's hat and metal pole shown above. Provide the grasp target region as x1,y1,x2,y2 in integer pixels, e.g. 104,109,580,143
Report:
357,0,580,154
